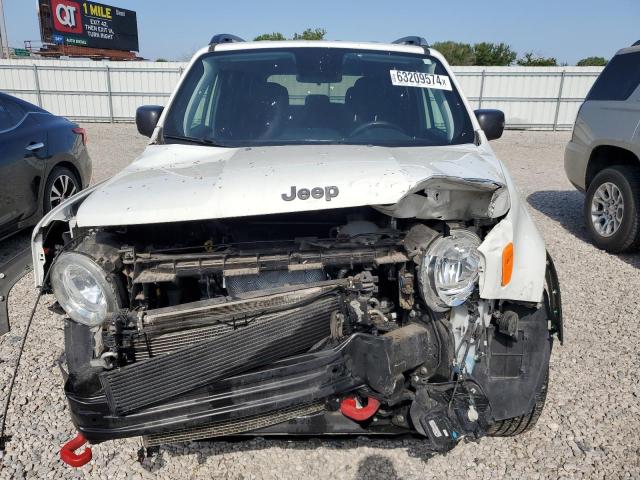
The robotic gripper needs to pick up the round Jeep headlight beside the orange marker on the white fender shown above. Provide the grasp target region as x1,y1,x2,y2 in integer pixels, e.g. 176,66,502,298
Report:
419,230,481,312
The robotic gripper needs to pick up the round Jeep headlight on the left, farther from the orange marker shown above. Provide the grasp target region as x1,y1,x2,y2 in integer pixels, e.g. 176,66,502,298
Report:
51,252,117,327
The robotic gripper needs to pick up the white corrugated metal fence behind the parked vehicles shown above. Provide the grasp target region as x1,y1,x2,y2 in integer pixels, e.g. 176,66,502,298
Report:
0,60,602,130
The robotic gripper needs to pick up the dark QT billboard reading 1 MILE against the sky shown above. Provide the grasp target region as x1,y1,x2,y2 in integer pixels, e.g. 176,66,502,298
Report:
39,0,139,52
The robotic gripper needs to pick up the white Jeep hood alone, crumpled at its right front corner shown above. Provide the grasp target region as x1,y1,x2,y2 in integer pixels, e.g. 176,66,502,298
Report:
76,145,505,227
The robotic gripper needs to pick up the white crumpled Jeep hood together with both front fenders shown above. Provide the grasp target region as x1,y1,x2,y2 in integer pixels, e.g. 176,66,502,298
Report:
32,138,546,302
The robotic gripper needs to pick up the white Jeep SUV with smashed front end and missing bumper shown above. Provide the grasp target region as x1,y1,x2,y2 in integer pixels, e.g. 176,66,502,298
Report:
33,37,562,458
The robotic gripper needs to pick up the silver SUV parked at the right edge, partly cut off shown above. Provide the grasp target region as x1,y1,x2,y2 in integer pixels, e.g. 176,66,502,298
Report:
564,41,640,253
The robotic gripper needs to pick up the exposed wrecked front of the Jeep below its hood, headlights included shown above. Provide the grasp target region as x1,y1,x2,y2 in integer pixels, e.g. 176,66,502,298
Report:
41,208,551,450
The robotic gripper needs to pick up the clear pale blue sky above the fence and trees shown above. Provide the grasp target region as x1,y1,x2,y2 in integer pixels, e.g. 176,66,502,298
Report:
3,0,640,65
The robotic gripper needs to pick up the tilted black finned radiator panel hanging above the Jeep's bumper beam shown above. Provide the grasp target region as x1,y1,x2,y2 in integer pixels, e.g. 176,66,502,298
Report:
100,295,341,415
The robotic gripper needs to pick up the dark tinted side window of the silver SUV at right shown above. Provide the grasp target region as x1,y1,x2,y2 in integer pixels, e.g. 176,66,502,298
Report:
586,52,640,100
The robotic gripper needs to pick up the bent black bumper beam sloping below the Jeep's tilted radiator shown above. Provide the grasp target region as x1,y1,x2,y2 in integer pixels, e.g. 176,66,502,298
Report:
65,322,435,443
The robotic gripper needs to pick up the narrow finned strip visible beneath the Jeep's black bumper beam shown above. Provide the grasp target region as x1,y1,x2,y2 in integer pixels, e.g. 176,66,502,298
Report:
144,403,324,447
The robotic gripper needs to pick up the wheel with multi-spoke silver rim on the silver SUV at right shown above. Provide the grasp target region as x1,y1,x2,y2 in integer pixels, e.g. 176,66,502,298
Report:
584,165,640,253
